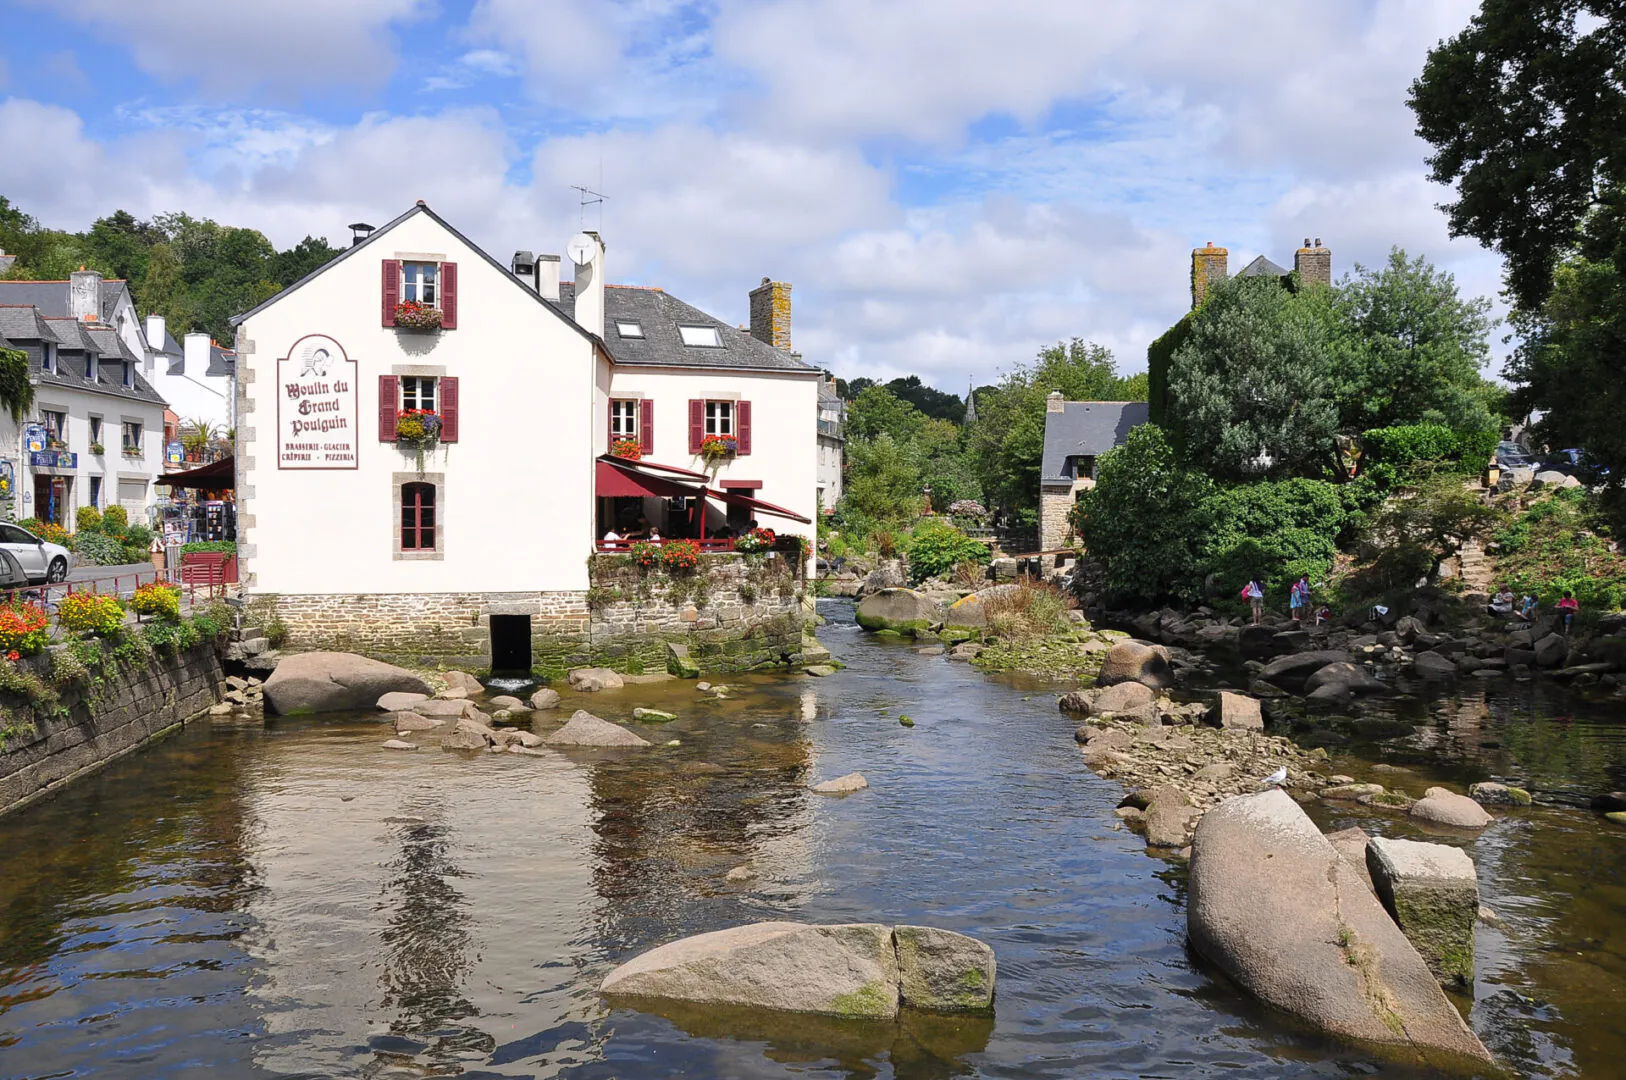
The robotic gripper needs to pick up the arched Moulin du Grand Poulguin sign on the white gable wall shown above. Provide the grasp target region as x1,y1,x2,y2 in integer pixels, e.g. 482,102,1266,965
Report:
276,333,358,468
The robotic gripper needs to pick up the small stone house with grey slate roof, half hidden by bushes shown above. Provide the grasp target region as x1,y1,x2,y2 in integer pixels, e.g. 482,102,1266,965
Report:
1039,392,1148,551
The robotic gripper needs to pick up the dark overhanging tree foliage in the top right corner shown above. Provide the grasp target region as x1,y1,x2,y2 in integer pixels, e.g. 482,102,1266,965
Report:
1410,0,1626,311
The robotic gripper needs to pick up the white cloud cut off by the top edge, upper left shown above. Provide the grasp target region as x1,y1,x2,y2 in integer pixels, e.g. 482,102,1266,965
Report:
29,0,429,101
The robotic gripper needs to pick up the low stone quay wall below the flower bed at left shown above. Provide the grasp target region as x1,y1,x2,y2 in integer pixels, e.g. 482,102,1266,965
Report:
0,642,226,815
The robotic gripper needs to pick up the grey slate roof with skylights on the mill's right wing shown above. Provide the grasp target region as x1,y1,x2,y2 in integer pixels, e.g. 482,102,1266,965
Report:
558,281,818,371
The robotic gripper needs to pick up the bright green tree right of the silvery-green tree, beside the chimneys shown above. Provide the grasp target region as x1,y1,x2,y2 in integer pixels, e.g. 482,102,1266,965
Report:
1330,247,1501,433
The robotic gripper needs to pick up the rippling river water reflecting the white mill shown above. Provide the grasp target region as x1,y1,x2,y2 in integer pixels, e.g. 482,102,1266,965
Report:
0,602,1626,1080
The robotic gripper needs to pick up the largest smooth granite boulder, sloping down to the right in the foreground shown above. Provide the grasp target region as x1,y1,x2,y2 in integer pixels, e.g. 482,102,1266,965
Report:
1187,790,1491,1069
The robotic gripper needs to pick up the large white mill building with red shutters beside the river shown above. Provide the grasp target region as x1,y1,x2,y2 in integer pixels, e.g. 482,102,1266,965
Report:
234,202,820,668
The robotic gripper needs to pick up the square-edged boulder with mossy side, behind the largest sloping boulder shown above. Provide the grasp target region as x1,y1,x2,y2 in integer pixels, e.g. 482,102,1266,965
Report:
1366,836,1480,986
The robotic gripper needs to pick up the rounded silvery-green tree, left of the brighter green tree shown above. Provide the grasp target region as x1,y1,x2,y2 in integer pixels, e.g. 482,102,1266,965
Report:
1167,278,1338,480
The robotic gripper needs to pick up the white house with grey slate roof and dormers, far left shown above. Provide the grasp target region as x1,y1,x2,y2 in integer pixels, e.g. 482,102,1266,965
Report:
0,272,164,529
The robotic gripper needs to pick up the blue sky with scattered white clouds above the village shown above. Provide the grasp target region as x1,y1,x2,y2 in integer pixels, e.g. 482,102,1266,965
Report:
0,0,1499,392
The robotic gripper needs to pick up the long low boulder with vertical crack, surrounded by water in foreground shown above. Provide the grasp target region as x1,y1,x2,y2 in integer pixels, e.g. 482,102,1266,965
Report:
600,922,993,1020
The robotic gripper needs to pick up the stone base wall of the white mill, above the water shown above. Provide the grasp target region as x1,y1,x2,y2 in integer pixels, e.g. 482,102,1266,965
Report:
247,553,806,678
